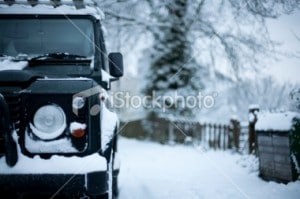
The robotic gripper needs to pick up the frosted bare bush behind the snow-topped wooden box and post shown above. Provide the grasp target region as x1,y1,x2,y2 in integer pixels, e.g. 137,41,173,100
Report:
225,77,297,119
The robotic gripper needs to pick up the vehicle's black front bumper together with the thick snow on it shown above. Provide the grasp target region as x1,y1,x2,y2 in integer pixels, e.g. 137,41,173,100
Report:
0,153,108,198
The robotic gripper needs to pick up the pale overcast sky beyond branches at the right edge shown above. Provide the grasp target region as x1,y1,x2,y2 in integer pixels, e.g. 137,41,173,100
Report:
265,11,300,83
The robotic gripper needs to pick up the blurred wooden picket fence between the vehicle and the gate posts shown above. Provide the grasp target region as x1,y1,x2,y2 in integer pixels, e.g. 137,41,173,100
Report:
120,118,244,150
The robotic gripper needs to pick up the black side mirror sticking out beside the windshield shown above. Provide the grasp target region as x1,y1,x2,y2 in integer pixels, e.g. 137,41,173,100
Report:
108,53,123,78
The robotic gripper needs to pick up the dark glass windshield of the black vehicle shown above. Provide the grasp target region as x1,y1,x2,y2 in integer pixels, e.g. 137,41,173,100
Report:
0,18,95,57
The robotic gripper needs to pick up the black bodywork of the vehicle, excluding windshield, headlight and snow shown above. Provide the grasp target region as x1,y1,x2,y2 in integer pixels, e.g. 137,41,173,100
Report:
0,14,116,198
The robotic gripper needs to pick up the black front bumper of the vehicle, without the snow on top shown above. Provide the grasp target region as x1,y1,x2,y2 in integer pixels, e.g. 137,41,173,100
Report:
0,171,108,198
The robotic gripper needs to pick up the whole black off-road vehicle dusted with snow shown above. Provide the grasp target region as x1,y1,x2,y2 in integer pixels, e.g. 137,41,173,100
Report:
0,0,123,198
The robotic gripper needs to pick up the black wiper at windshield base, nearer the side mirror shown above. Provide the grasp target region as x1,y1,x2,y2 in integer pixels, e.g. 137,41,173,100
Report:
28,53,91,66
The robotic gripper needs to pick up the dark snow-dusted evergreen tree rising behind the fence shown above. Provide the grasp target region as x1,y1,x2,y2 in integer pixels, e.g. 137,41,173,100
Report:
145,0,203,116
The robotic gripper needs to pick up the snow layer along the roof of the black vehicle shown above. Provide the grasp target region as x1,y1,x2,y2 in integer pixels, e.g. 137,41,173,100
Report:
0,0,104,19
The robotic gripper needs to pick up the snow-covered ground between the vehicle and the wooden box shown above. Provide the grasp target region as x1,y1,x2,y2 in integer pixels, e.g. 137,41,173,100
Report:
119,138,300,199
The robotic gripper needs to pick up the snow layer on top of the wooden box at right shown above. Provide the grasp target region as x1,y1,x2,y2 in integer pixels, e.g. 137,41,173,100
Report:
255,112,300,131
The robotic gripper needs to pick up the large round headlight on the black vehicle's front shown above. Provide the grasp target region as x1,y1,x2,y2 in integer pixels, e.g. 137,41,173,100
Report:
30,105,67,140
